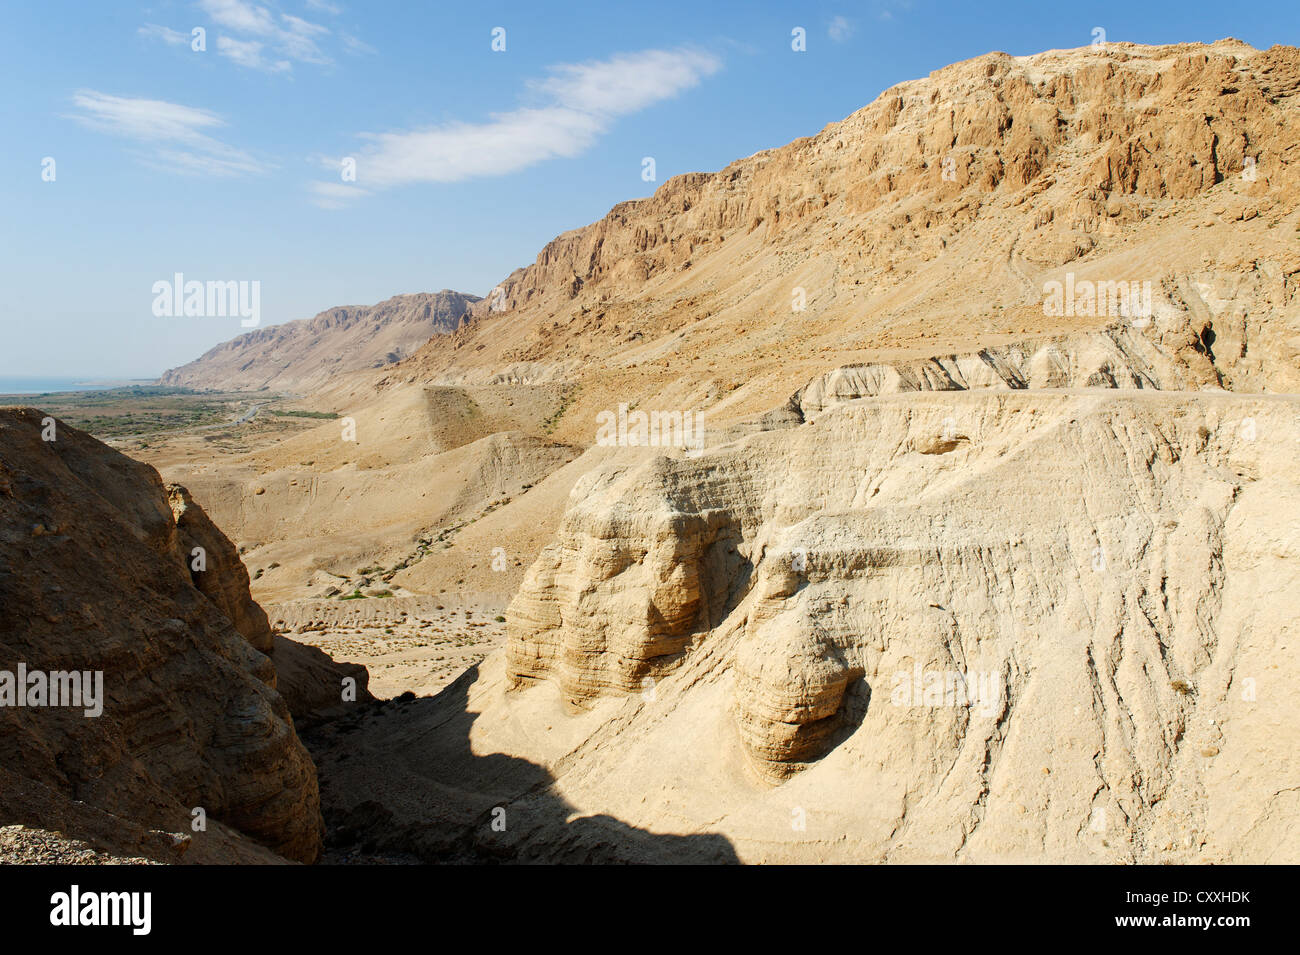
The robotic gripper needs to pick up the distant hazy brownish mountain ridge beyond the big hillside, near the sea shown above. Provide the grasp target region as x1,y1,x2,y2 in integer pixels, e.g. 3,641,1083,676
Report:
160,288,478,392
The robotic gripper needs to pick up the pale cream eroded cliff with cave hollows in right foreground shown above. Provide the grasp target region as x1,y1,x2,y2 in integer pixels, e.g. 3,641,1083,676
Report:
496,390,1300,863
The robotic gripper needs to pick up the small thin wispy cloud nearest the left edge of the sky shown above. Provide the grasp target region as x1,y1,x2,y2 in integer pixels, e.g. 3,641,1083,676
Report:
70,90,267,177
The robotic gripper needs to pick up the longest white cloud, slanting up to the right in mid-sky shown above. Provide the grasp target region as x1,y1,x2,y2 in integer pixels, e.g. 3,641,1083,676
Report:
317,49,722,204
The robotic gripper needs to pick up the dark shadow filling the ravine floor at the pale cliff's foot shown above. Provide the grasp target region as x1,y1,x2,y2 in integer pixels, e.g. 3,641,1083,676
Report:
297,665,738,863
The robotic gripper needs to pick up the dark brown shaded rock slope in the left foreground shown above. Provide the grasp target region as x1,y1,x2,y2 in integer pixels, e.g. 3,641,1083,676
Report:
0,409,321,861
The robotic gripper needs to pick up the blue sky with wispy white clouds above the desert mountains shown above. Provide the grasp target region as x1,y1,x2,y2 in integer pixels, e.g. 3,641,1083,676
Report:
0,0,1300,377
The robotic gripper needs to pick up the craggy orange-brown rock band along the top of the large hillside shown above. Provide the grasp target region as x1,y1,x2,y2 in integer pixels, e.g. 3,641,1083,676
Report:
473,40,1300,314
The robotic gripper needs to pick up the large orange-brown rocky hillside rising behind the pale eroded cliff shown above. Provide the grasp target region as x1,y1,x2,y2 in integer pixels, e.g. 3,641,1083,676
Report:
364,40,1300,426
